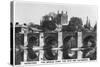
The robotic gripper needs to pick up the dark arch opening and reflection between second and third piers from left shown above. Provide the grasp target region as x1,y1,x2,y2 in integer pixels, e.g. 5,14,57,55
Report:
44,36,58,60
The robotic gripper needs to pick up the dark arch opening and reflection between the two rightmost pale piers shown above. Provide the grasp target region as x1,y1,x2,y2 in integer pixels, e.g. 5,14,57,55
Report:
63,36,77,59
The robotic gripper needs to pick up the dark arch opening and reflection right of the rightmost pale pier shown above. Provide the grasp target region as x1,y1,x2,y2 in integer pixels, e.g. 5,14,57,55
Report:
83,35,96,60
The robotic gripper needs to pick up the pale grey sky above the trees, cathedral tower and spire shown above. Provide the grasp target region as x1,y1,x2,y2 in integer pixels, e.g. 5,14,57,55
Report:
15,1,98,26
